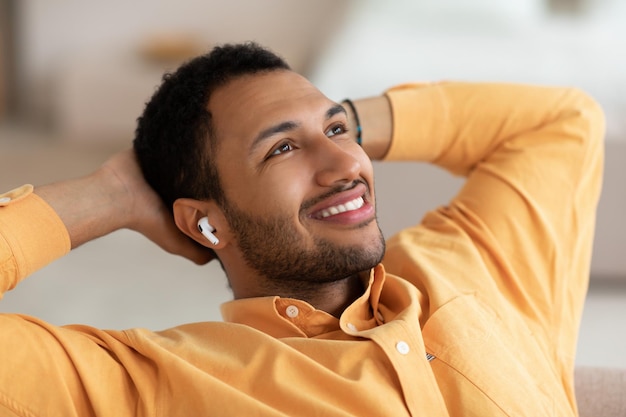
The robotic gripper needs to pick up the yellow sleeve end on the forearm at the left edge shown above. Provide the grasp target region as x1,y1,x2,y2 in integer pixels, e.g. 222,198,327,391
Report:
0,185,71,297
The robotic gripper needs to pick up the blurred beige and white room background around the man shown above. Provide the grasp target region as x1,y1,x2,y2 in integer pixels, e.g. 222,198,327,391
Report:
0,0,626,366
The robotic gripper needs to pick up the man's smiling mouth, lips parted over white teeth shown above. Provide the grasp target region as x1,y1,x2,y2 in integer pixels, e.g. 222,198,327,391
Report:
309,183,373,220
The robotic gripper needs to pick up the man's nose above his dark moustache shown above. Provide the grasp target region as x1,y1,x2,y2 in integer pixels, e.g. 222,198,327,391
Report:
315,137,361,187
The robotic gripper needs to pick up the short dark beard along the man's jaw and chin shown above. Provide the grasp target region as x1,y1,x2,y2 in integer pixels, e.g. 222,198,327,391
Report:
223,193,385,289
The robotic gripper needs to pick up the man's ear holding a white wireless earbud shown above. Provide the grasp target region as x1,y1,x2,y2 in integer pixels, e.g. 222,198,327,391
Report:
173,198,228,249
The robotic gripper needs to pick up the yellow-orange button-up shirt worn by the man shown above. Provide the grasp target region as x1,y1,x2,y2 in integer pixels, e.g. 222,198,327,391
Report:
0,83,604,417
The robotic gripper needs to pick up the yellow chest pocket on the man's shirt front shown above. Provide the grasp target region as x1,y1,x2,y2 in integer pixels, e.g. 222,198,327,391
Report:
422,294,575,417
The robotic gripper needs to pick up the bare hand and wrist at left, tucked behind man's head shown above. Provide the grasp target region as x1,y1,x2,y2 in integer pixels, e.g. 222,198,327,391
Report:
35,150,213,264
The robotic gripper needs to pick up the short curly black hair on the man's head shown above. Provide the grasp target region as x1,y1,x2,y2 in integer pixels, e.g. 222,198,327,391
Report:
133,42,290,211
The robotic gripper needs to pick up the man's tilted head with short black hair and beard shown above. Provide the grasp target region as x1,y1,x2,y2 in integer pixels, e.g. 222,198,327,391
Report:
135,44,384,297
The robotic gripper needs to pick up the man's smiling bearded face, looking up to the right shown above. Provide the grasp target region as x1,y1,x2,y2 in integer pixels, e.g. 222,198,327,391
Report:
208,71,384,283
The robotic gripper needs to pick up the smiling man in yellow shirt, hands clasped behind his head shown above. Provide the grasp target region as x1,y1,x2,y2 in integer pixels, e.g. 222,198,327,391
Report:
0,44,603,416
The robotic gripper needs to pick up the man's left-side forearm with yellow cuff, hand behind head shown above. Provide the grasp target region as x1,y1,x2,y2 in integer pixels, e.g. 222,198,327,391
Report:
0,150,212,295
